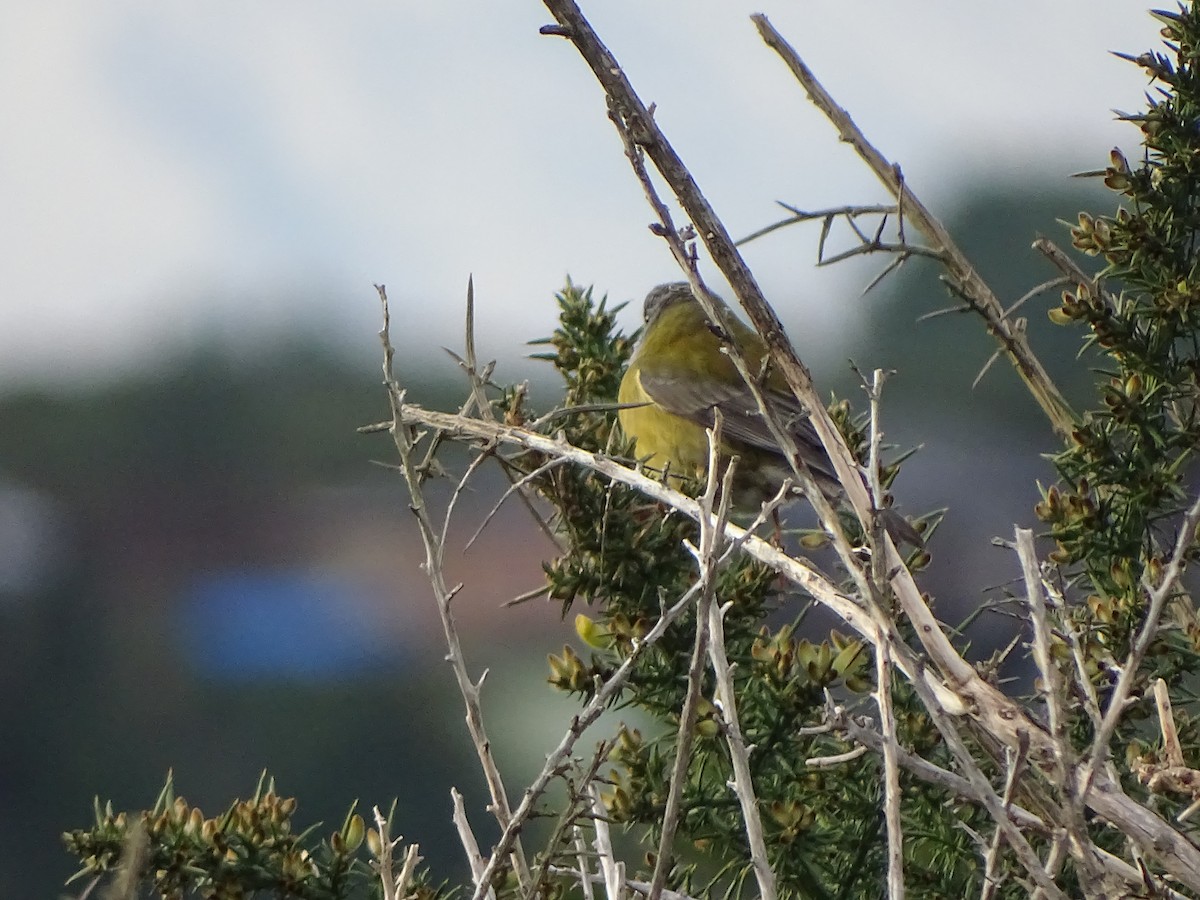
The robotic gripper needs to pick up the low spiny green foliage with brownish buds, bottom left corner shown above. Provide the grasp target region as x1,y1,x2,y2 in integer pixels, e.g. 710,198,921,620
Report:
62,773,446,900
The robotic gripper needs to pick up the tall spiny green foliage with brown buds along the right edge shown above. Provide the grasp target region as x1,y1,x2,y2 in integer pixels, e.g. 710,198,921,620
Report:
1037,6,1200,715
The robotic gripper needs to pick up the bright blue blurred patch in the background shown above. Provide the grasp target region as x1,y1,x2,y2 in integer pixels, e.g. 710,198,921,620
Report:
179,570,404,679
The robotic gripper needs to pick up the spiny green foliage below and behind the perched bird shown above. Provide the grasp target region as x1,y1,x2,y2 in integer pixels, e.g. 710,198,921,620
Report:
529,283,993,898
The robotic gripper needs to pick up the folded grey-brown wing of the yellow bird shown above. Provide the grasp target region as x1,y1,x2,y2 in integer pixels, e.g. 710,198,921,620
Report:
638,368,836,480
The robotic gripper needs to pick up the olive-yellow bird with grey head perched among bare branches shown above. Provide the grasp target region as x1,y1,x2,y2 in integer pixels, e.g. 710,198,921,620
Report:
617,282,923,546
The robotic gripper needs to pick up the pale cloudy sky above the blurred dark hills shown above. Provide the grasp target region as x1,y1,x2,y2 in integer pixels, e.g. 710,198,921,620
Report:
0,0,1159,391
